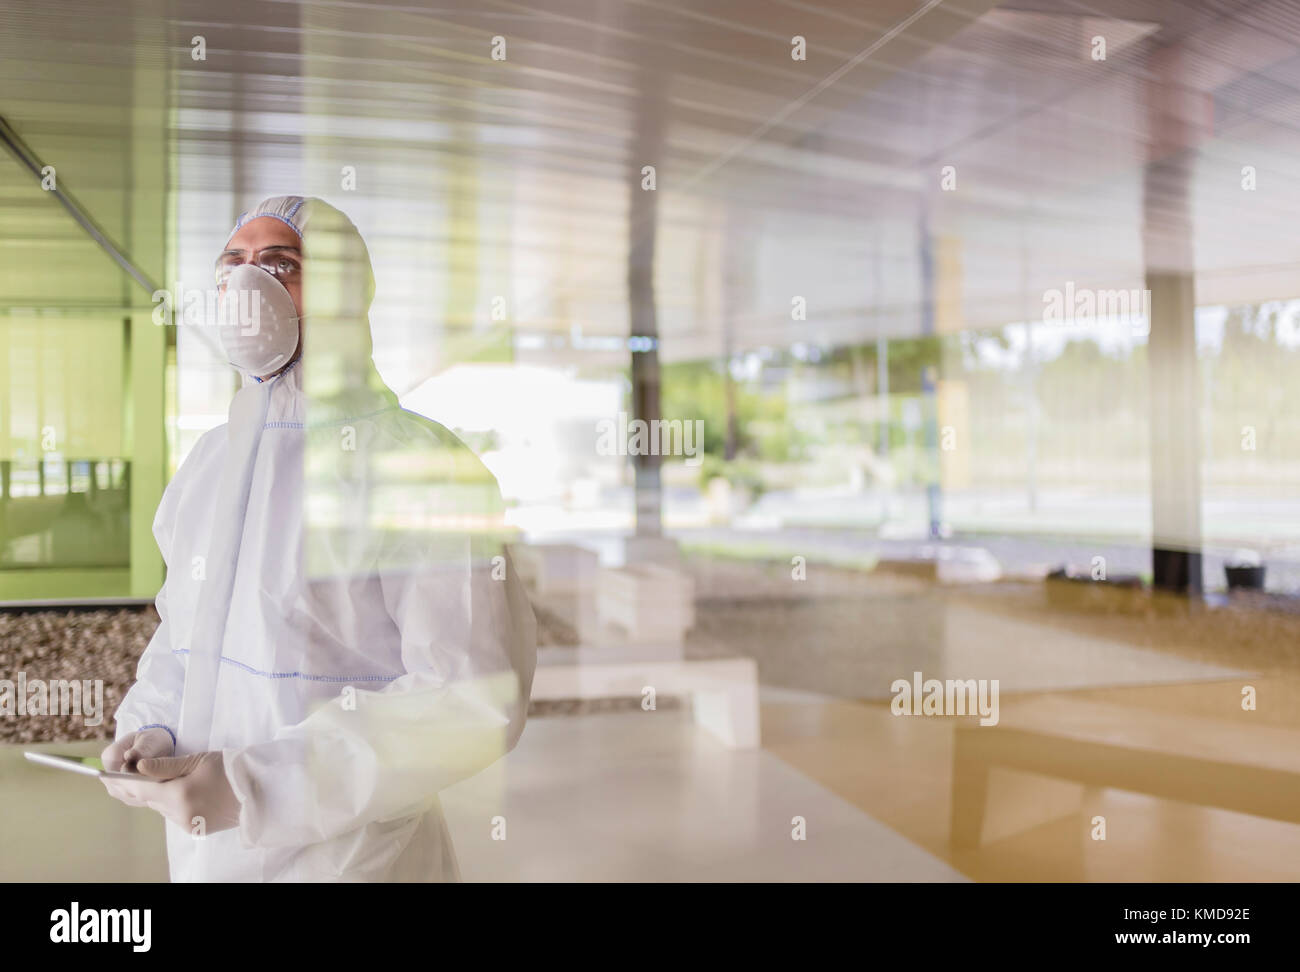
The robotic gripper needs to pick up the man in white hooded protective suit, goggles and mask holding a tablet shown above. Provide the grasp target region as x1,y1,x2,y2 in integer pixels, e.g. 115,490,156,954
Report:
103,196,536,881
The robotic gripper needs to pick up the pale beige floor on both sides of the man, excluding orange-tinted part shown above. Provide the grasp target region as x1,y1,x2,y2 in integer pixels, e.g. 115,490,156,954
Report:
0,710,965,881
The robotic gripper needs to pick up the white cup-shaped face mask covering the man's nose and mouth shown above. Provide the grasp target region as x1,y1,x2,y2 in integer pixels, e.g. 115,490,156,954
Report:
220,264,299,378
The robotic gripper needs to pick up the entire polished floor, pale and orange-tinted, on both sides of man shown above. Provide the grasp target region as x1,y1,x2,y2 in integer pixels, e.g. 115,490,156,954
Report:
0,569,1300,881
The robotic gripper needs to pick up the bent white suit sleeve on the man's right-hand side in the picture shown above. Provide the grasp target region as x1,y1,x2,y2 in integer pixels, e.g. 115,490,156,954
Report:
224,535,537,847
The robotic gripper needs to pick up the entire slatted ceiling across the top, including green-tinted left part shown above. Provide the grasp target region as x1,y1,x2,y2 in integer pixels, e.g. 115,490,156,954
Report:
0,0,1300,379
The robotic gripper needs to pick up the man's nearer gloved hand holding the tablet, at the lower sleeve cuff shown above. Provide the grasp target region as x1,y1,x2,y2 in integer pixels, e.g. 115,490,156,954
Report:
100,751,239,837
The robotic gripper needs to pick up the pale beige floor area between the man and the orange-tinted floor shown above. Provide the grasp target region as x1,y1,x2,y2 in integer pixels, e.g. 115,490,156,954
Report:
442,712,963,881
